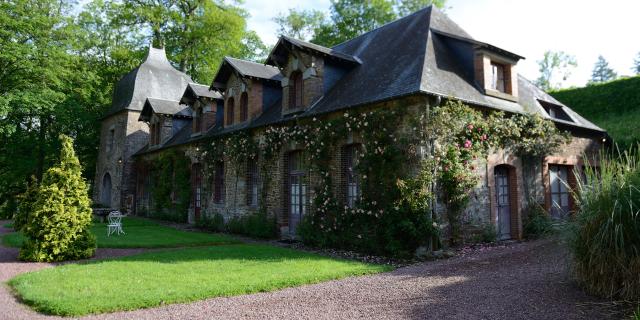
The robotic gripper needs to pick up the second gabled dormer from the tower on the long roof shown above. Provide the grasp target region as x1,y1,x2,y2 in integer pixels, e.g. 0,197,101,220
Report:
180,83,224,136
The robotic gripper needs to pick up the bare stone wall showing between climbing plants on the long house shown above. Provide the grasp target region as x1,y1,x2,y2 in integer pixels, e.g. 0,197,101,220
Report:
131,97,601,239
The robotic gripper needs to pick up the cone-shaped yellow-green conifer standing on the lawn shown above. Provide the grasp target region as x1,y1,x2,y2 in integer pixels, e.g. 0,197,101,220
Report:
19,135,96,262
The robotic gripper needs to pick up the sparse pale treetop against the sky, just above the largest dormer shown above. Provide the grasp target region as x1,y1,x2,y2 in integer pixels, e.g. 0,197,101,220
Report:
273,9,326,41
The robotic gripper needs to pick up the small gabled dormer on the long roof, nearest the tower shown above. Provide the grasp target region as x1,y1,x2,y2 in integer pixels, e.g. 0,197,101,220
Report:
138,98,192,148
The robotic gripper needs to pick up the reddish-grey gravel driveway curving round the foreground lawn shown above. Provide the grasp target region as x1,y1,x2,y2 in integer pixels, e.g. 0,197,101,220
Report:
0,220,619,319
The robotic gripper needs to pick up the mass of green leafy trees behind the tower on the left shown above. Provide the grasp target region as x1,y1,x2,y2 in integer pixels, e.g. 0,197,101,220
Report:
0,0,266,216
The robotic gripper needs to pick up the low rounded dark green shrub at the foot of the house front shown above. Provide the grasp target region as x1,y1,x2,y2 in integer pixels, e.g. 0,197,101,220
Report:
226,210,279,239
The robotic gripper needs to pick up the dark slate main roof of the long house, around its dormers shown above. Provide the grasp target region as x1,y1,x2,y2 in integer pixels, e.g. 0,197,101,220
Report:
134,6,604,156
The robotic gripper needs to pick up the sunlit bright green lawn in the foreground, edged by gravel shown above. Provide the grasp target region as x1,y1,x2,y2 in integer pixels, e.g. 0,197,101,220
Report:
9,245,391,316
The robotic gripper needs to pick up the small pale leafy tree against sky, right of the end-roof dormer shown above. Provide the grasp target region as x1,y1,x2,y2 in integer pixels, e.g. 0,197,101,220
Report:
536,51,578,91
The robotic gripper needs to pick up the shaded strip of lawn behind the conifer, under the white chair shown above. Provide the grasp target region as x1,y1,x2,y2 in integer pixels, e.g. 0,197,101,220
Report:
2,217,238,248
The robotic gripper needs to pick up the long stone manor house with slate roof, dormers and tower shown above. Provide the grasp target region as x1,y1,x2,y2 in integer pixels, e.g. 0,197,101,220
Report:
94,7,606,239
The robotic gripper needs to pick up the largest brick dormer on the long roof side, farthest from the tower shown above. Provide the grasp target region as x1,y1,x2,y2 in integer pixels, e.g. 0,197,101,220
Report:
266,36,362,115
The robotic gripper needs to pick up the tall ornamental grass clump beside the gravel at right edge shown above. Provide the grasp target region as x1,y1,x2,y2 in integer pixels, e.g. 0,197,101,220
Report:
572,152,640,301
